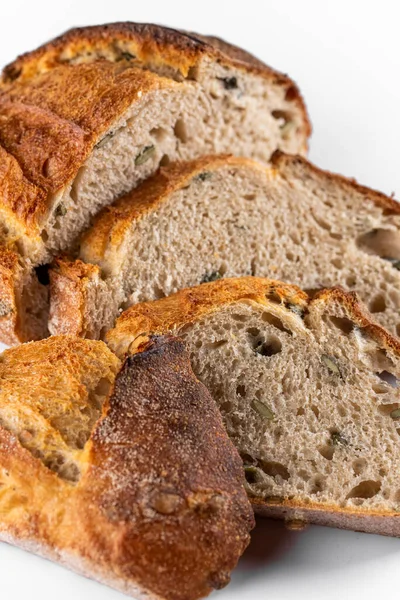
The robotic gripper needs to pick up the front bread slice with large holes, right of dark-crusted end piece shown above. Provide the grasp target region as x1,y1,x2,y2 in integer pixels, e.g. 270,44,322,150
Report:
108,277,400,536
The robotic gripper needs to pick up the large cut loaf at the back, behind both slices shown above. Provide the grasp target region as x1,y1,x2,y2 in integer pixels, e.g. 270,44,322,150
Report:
0,23,310,343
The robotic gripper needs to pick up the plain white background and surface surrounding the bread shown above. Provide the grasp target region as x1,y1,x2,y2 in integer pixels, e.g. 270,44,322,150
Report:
0,0,400,600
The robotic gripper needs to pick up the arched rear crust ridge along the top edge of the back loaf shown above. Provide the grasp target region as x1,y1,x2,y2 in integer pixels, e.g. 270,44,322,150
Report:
2,22,310,105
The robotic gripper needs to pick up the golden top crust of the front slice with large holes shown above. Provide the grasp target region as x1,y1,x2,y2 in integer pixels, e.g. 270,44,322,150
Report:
106,276,400,356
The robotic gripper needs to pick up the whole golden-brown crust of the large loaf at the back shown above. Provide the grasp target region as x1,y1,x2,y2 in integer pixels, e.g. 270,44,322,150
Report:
0,23,310,236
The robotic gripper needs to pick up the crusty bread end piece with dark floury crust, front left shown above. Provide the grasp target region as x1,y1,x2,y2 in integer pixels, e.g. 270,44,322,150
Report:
0,336,253,600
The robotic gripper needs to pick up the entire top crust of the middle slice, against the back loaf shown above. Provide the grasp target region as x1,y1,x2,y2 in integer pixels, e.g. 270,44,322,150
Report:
81,151,400,263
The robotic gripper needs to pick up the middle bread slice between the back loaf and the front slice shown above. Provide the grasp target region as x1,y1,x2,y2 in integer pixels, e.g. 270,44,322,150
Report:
49,153,400,338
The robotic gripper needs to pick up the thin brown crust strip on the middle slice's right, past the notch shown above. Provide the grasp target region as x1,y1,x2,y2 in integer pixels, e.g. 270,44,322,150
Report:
271,150,400,215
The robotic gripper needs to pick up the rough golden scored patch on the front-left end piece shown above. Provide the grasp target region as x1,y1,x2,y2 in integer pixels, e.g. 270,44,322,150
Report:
0,336,120,482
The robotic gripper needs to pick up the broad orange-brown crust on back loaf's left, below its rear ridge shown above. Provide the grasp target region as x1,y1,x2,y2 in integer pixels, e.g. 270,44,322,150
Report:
0,61,170,236
